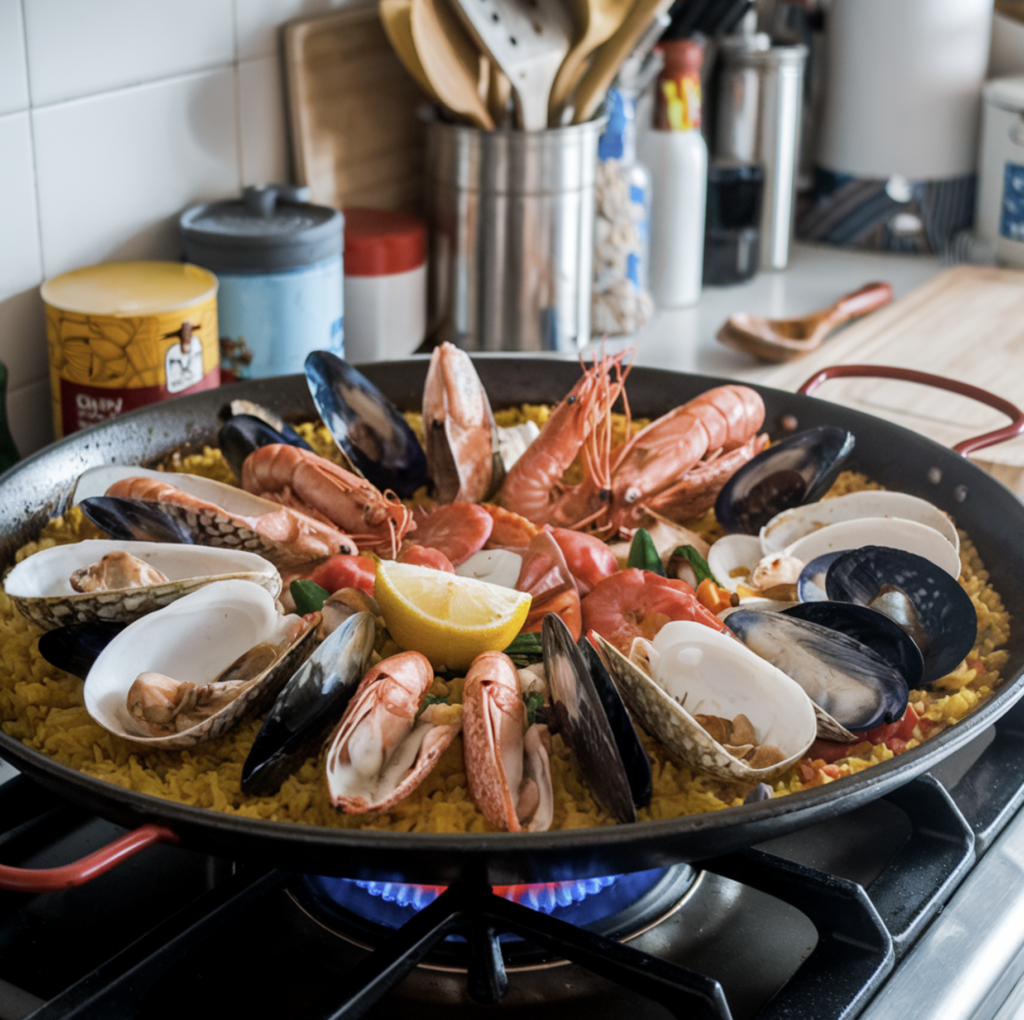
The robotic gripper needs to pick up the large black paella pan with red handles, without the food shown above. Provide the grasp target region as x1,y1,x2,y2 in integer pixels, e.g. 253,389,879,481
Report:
0,357,1024,889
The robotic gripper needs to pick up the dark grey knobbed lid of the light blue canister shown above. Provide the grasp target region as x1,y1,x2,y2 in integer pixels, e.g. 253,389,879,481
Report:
178,185,345,272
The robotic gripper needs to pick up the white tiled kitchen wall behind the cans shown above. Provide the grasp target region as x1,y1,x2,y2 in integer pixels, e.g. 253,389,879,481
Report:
0,0,367,455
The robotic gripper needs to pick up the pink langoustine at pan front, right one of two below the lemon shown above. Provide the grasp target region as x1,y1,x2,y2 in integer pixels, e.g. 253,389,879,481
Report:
462,651,554,833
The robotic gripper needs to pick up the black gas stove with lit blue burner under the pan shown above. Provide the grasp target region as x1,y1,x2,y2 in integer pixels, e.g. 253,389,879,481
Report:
6,706,1024,1020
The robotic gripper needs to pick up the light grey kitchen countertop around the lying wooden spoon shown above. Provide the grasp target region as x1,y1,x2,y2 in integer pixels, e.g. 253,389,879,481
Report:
589,244,943,382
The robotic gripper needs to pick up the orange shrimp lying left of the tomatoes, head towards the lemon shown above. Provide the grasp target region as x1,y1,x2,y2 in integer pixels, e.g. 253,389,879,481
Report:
242,443,415,558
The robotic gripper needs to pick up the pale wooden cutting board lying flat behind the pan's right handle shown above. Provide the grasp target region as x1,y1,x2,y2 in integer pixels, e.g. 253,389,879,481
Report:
758,266,1024,496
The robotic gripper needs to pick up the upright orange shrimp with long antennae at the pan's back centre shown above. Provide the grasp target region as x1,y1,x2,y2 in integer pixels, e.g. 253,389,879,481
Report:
498,353,629,527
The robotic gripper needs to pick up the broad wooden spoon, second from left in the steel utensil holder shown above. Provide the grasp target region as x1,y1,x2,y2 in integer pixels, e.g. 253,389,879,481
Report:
411,0,495,131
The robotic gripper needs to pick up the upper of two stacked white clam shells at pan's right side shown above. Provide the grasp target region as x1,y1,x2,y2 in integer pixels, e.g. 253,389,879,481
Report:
761,491,959,553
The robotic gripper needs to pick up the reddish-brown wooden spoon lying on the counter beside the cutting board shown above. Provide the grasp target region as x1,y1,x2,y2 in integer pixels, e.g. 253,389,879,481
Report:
717,284,893,362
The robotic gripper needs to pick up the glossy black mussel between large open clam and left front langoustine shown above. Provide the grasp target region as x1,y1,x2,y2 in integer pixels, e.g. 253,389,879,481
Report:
242,612,377,797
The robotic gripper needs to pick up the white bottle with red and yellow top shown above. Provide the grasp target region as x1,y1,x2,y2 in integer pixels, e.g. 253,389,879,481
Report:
640,39,708,308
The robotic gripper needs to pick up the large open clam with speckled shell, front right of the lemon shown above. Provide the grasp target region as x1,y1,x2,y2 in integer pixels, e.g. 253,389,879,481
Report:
599,621,817,782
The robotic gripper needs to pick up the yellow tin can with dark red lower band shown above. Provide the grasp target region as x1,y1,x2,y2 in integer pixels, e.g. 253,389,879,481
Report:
40,262,220,438
